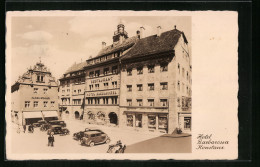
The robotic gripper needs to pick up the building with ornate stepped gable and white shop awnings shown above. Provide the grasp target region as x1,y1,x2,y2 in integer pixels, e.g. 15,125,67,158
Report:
11,62,59,125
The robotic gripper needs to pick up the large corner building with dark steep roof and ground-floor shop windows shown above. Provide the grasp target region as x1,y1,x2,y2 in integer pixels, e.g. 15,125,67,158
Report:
119,26,192,133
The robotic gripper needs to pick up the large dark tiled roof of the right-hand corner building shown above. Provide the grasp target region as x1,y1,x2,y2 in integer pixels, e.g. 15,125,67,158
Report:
121,29,188,60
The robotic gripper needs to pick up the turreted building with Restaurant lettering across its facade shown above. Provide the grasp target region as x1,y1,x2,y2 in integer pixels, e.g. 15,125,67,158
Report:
84,23,138,125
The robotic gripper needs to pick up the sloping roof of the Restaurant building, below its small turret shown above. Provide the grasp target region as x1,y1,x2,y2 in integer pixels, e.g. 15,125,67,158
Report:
92,36,138,59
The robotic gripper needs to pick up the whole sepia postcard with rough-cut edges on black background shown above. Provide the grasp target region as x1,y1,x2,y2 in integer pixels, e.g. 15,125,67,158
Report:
5,11,238,160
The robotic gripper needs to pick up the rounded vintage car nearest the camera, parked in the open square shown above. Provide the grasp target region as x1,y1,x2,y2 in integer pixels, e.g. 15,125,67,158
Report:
80,130,110,147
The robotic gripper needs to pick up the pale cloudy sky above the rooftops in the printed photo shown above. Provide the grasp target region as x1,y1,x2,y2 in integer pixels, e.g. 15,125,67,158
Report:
11,16,191,84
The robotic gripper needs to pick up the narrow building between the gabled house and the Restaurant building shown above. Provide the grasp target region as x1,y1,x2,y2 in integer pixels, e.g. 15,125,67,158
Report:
59,62,86,119
